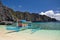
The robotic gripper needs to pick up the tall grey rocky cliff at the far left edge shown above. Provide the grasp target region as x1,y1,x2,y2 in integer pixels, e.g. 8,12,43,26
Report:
0,2,14,21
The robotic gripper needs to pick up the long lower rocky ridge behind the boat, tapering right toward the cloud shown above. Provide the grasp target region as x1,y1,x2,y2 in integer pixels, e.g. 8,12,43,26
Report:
16,12,57,22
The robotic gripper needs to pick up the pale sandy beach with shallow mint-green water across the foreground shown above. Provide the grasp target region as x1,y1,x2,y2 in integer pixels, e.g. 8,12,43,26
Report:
0,25,60,40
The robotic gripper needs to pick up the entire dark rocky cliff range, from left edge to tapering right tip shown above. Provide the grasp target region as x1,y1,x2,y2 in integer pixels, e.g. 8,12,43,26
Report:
0,2,58,22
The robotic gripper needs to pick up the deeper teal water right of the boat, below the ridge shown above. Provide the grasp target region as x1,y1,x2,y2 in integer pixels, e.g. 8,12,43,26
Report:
30,22,60,30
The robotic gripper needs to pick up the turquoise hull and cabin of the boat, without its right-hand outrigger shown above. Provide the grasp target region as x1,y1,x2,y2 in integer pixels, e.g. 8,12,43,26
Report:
6,20,31,33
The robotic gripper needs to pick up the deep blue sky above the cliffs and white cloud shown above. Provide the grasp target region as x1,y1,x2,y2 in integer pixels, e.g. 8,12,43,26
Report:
2,0,60,13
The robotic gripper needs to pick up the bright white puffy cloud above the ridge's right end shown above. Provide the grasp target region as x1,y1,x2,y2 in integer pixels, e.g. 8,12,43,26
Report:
39,10,60,20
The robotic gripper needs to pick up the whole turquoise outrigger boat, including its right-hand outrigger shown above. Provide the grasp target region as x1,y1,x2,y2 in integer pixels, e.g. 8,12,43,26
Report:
6,20,40,33
